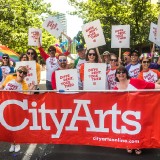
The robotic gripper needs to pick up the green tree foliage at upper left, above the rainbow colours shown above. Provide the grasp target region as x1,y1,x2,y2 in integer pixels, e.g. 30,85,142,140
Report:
0,0,56,53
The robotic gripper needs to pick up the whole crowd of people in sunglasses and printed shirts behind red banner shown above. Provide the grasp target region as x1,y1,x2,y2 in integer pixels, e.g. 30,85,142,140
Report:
0,37,160,154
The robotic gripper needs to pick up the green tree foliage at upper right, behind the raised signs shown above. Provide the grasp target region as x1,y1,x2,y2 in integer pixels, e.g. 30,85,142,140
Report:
68,0,159,51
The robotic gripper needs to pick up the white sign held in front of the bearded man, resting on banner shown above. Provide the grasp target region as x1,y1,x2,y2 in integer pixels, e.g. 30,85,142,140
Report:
55,69,78,90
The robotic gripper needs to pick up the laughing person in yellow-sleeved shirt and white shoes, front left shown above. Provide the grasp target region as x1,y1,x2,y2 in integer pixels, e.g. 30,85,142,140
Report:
0,66,34,152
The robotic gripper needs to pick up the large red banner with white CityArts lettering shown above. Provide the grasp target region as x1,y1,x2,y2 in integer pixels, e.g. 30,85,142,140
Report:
0,91,160,148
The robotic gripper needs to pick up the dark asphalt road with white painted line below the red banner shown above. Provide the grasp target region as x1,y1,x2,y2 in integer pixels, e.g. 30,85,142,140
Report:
0,142,160,160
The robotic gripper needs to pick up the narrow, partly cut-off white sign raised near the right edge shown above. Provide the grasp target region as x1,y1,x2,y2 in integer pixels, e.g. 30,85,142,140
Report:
149,22,157,43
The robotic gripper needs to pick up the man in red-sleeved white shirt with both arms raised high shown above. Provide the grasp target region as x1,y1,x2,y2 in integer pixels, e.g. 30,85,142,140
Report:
37,33,71,90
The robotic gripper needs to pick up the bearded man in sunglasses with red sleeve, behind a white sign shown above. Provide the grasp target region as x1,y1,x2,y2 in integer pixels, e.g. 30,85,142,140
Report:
51,53,69,90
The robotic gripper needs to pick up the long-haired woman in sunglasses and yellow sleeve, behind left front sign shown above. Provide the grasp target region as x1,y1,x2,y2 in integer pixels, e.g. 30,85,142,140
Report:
27,48,41,94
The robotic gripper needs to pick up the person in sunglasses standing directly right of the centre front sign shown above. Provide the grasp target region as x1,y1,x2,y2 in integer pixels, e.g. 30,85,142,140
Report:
106,53,118,90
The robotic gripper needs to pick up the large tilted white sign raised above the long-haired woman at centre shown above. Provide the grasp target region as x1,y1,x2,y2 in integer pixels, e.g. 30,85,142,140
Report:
82,20,106,49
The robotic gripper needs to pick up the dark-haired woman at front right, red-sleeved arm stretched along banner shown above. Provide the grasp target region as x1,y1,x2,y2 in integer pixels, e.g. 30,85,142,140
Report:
114,66,160,155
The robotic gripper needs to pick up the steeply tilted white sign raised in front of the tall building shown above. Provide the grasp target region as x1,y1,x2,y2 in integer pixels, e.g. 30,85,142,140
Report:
42,16,64,38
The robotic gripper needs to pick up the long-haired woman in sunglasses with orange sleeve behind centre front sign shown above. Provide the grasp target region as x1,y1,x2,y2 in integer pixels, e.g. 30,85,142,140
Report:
80,48,98,86
